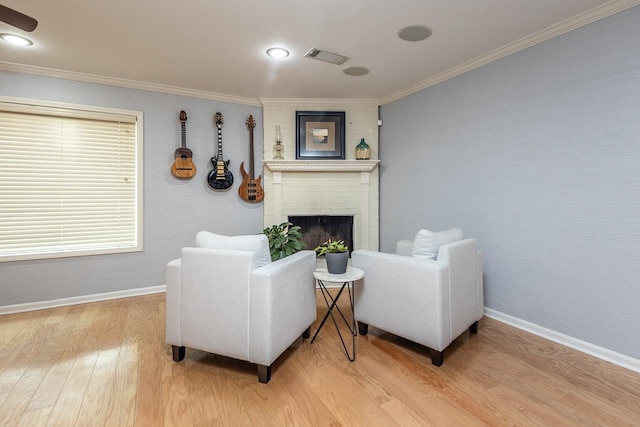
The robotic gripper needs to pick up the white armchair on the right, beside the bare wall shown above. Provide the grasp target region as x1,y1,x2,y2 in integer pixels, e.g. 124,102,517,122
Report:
351,239,484,366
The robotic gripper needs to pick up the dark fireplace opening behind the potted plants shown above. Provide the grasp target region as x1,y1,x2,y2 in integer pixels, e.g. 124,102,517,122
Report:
289,215,353,252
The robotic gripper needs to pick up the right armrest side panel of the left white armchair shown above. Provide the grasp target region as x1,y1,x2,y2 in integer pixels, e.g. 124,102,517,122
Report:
249,250,317,365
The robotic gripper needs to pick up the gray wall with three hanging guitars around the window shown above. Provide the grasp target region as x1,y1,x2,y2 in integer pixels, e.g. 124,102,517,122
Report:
0,72,263,306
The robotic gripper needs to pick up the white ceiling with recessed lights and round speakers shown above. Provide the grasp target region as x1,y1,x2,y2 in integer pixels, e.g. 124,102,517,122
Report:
0,0,638,100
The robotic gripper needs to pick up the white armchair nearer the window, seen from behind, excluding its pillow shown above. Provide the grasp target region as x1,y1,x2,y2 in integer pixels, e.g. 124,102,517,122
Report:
166,232,316,383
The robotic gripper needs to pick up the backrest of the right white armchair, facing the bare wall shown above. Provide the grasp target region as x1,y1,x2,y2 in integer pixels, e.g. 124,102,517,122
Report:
438,239,483,337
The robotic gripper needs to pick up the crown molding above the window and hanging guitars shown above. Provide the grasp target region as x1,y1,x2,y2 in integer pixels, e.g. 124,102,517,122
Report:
0,61,262,107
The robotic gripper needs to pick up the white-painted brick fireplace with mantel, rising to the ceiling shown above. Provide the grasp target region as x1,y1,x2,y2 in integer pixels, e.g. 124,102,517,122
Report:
261,99,379,254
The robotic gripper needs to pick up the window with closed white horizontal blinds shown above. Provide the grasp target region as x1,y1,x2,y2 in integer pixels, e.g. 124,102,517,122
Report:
0,98,142,261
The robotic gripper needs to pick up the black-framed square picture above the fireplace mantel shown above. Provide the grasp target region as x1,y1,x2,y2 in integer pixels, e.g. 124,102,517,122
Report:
296,111,345,160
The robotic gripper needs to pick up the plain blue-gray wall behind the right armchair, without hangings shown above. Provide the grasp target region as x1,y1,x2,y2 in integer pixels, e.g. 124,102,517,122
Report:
380,7,640,358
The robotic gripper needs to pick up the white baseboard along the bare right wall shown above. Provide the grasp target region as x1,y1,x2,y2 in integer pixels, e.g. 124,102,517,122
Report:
484,307,640,373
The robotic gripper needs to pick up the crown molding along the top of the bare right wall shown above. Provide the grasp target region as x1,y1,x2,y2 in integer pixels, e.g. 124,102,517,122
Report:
380,0,640,105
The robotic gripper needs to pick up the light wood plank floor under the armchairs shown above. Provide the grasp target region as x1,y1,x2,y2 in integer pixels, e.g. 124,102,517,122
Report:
0,294,640,426
